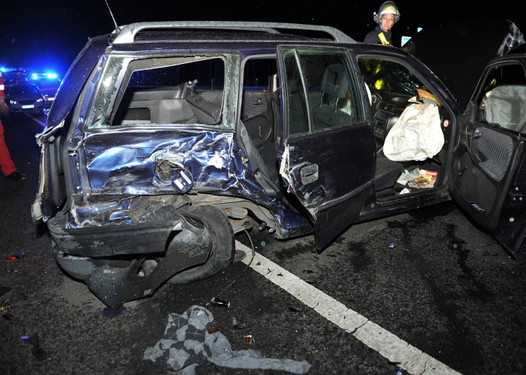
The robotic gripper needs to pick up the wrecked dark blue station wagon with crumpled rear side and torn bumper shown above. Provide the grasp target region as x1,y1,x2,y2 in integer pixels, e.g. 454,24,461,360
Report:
32,22,524,307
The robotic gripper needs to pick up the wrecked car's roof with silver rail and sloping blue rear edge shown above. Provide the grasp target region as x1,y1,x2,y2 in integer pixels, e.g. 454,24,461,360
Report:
48,21,356,129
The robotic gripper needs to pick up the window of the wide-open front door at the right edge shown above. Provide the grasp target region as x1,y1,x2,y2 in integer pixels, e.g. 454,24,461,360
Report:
476,63,526,133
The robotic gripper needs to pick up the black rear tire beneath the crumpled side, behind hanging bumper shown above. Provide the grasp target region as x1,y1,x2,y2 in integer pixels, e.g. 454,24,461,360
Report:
168,206,235,284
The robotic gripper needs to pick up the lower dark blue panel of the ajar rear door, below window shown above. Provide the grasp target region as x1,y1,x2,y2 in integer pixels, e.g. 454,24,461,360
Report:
287,124,374,249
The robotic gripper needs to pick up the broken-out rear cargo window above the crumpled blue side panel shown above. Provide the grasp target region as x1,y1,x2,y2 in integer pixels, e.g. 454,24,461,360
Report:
87,56,225,127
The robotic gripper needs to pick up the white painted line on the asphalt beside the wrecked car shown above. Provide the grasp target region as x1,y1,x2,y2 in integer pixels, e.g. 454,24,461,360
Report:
236,241,460,375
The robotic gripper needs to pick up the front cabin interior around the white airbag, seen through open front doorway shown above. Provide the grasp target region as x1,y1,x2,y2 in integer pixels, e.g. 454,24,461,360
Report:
359,57,451,203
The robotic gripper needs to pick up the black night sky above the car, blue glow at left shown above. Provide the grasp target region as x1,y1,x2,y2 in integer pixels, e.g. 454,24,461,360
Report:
0,0,526,73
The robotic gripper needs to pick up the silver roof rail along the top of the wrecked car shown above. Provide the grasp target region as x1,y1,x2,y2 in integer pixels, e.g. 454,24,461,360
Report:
113,21,356,44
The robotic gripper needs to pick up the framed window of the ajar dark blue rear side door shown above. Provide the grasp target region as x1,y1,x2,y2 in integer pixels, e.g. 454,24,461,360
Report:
283,49,363,136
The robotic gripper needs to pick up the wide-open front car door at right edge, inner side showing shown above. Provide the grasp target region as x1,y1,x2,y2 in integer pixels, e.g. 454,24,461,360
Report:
450,57,526,256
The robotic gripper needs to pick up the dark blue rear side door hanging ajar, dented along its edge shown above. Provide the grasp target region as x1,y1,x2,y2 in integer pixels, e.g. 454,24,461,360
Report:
279,46,376,249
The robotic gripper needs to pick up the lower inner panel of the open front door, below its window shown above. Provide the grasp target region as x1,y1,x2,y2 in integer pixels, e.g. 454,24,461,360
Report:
451,122,526,254
